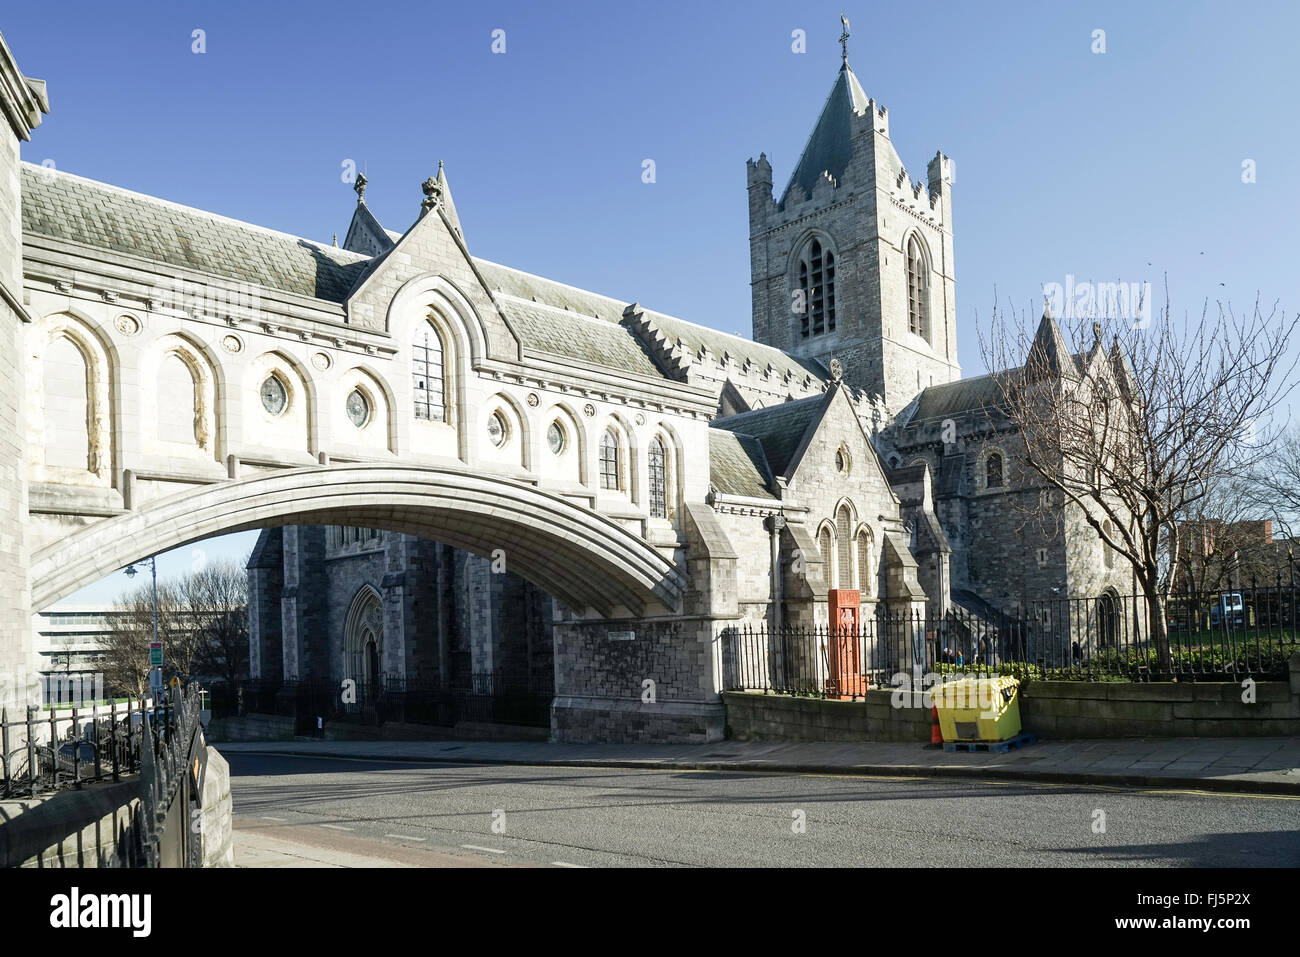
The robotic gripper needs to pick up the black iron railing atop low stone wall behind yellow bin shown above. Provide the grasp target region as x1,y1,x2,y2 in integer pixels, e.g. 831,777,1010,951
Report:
722,585,1300,698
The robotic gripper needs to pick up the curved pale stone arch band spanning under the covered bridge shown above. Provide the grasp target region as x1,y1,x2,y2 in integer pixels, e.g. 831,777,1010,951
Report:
31,464,685,618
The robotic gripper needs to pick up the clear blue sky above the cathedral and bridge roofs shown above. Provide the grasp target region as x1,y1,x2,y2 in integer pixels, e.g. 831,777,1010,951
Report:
12,0,1300,605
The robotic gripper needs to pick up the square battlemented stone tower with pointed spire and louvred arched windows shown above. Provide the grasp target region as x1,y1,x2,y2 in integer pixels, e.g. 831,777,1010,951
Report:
746,43,961,413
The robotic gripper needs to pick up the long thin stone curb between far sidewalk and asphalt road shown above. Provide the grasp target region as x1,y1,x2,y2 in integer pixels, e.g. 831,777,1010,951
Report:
230,749,1300,794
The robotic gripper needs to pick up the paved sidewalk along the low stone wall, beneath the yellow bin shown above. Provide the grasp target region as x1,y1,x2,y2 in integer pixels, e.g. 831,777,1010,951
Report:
218,737,1300,794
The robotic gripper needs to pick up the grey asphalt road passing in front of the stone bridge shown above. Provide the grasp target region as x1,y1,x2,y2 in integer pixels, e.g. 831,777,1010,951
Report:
226,753,1300,867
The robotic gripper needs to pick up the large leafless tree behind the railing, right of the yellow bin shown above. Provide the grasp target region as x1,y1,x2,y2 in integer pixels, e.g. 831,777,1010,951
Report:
980,291,1300,674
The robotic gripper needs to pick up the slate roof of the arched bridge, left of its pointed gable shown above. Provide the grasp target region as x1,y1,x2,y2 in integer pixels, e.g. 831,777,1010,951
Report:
21,163,368,303
